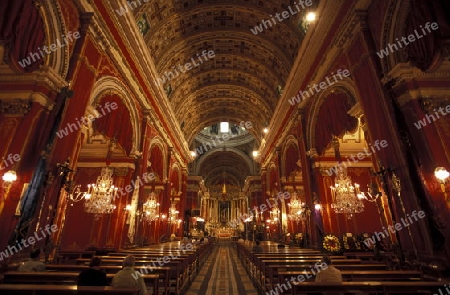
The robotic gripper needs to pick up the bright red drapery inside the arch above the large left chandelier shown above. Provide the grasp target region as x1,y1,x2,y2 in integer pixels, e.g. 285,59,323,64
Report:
93,95,133,155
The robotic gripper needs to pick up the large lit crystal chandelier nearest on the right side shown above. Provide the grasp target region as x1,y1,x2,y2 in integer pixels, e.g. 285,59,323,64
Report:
330,167,364,219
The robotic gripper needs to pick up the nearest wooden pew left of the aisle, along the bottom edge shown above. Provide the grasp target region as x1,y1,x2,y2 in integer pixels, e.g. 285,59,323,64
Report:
0,284,139,295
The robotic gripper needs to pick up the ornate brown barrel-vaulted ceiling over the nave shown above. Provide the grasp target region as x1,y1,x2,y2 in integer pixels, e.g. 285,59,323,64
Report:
133,0,306,143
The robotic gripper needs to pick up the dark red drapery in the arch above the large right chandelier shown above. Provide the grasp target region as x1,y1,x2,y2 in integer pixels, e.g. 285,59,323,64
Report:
315,92,358,155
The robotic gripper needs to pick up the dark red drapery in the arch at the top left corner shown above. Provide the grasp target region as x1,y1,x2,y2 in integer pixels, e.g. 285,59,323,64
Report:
0,0,45,72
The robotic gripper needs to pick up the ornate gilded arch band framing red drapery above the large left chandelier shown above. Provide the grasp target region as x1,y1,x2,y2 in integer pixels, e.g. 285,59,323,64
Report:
89,76,141,155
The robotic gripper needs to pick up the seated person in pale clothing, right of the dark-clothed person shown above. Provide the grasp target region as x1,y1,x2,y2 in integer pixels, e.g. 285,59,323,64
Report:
111,255,147,295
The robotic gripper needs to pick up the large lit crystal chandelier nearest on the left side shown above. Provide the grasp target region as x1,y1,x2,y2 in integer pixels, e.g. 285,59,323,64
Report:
84,167,118,214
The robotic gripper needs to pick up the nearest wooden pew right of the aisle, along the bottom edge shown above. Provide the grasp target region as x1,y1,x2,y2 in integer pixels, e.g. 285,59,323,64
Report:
288,281,449,295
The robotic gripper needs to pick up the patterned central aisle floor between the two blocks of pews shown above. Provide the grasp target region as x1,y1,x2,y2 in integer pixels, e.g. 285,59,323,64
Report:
186,241,258,295
